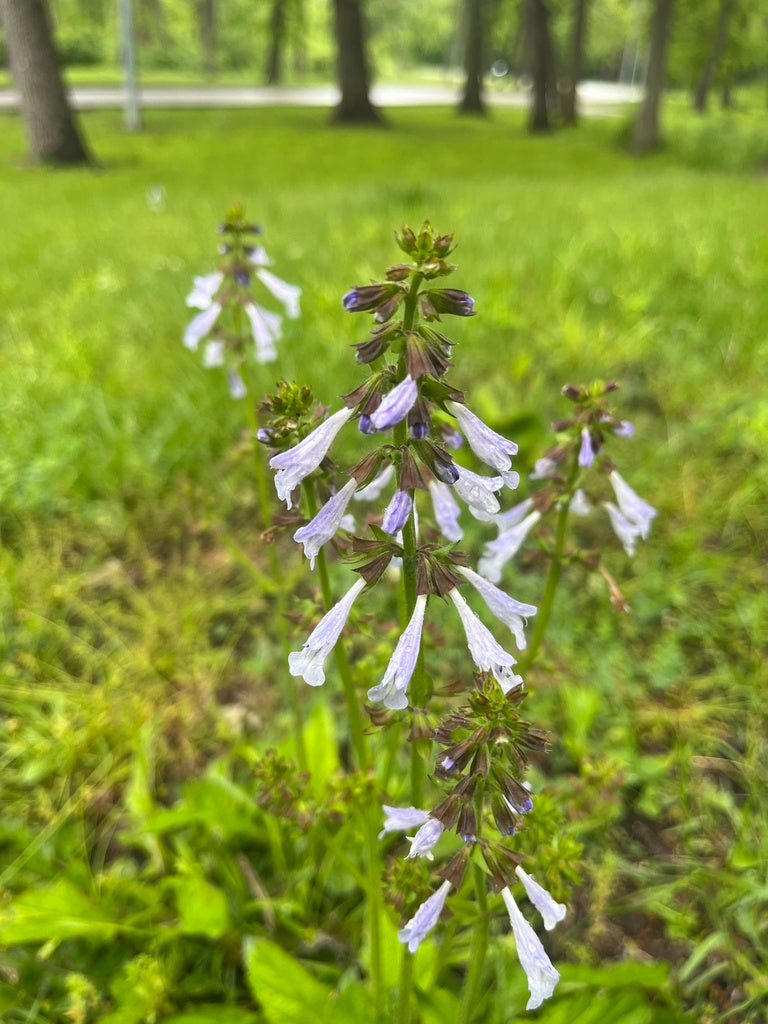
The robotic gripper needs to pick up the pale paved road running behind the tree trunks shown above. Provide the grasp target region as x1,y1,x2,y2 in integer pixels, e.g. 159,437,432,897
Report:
0,82,641,116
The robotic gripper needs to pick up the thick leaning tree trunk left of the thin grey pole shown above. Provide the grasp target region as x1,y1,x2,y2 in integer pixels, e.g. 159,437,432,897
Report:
0,0,91,164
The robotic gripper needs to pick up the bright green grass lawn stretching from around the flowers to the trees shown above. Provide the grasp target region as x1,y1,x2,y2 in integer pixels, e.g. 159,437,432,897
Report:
0,108,768,1024
